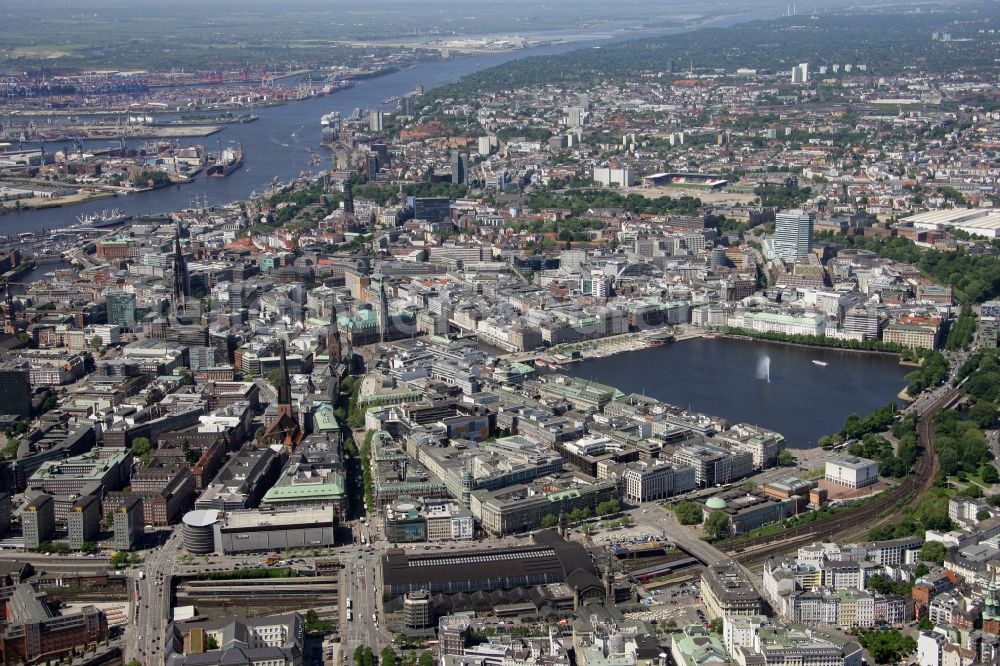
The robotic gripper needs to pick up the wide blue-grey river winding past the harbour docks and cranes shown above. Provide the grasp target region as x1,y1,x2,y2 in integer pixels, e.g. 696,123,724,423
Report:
0,13,780,233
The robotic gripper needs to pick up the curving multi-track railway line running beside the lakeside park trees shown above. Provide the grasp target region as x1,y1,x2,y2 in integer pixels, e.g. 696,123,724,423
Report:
726,389,961,565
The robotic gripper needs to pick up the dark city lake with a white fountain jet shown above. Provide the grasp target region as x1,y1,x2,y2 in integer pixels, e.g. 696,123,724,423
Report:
563,338,907,449
